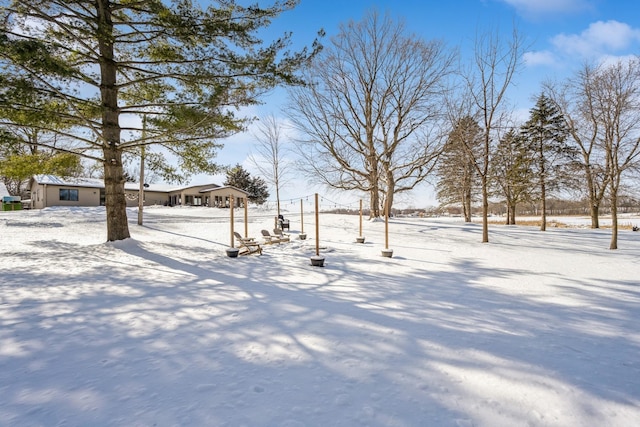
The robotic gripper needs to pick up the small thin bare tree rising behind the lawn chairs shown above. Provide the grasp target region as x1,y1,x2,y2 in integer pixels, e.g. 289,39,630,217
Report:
249,115,291,215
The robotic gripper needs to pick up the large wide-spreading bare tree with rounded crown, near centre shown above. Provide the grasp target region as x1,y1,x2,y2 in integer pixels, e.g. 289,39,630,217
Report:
289,12,455,217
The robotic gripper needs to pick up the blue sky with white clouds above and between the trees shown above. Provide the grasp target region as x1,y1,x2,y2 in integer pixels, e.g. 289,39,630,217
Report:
201,0,640,206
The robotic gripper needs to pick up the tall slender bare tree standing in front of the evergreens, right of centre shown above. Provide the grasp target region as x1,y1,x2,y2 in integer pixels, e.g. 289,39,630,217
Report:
462,29,524,243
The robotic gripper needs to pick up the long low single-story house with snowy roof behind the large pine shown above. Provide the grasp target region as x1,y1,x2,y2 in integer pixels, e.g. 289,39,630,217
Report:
29,175,248,209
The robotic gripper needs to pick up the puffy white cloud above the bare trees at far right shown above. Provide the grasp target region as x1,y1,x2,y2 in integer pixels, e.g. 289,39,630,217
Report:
551,21,640,57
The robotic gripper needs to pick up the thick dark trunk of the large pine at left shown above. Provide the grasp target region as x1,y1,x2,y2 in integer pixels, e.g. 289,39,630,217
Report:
96,0,130,242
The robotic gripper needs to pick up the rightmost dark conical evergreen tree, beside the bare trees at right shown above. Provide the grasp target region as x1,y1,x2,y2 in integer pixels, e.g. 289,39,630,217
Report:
521,93,576,231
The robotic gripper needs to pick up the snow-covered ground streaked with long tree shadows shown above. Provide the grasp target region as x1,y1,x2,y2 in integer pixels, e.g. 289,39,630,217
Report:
0,208,640,427
